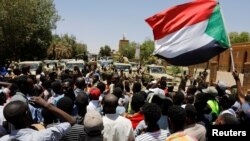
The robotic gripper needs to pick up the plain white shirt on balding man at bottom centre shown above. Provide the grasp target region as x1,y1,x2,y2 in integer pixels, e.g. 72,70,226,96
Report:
102,114,135,141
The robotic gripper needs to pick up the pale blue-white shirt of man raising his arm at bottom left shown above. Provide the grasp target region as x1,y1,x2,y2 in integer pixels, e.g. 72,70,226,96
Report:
0,122,71,141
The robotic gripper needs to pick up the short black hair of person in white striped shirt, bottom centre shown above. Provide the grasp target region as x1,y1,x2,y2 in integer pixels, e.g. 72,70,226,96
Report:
142,103,161,125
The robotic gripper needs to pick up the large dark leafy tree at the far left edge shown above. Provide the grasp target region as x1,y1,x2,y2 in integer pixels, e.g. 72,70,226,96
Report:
0,0,60,60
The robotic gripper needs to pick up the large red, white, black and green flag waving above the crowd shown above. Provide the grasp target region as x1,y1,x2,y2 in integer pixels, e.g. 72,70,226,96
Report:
145,1,230,66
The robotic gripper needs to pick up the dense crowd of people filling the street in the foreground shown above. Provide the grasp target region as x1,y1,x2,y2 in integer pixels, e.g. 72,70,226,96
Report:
0,63,250,141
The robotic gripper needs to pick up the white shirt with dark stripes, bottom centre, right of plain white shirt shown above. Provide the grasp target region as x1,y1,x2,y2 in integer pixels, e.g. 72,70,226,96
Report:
135,129,170,141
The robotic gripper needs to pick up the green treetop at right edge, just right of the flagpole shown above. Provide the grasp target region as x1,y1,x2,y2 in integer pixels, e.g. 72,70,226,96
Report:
229,32,250,44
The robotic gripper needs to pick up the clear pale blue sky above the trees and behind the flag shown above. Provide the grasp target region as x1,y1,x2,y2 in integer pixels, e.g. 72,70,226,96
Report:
53,0,250,53
